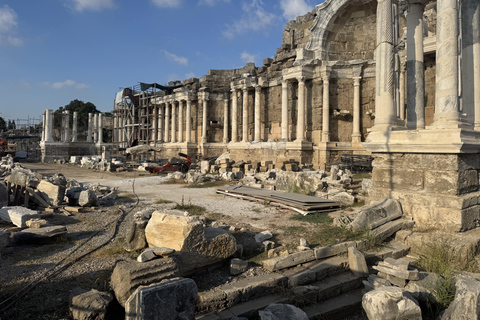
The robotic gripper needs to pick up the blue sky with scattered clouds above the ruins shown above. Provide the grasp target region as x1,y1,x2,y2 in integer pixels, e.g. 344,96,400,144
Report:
0,0,323,123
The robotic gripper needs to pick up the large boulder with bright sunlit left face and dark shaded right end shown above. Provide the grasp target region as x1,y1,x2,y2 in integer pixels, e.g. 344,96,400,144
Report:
145,211,237,269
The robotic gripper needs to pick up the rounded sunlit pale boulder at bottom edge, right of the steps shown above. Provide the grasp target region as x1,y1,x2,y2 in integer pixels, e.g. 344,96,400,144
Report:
362,287,422,320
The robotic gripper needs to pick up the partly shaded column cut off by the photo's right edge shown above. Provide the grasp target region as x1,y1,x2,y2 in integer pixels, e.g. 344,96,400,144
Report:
461,0,480,130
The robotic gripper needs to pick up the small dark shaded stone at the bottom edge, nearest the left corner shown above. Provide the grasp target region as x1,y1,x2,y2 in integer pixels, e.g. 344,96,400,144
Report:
70,288,113,320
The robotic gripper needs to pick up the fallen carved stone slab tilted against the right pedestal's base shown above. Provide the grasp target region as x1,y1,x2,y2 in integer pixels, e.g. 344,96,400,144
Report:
350,199,403,231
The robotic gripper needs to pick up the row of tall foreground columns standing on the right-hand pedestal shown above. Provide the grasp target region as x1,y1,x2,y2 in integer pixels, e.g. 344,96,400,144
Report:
373,0,480,131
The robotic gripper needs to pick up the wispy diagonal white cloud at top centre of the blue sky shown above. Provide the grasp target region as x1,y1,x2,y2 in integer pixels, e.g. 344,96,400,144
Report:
223,0,276,39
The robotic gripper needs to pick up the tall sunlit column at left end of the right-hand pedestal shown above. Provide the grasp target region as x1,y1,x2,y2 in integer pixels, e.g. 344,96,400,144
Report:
372,0,396,131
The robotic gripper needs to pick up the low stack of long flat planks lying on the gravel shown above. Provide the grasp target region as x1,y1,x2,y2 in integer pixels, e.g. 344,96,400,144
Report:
217,186,340,215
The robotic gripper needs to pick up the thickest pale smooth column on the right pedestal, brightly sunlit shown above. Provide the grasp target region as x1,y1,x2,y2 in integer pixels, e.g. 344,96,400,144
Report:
433,0,460,128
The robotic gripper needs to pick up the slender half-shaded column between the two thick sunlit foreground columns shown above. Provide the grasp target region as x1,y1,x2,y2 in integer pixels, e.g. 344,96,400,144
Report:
407,3,425,130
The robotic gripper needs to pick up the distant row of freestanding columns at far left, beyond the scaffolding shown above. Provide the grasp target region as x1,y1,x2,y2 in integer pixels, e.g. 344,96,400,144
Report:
42,109,103,143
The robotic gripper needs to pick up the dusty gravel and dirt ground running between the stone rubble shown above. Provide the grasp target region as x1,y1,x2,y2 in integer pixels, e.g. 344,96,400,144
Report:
0,163,356,320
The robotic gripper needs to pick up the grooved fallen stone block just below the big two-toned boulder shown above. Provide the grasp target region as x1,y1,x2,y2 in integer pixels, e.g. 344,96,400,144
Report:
110,256,186,307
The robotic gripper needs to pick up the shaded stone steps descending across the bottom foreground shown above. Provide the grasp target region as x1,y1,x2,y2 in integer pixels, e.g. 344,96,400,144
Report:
196,243,408,320
